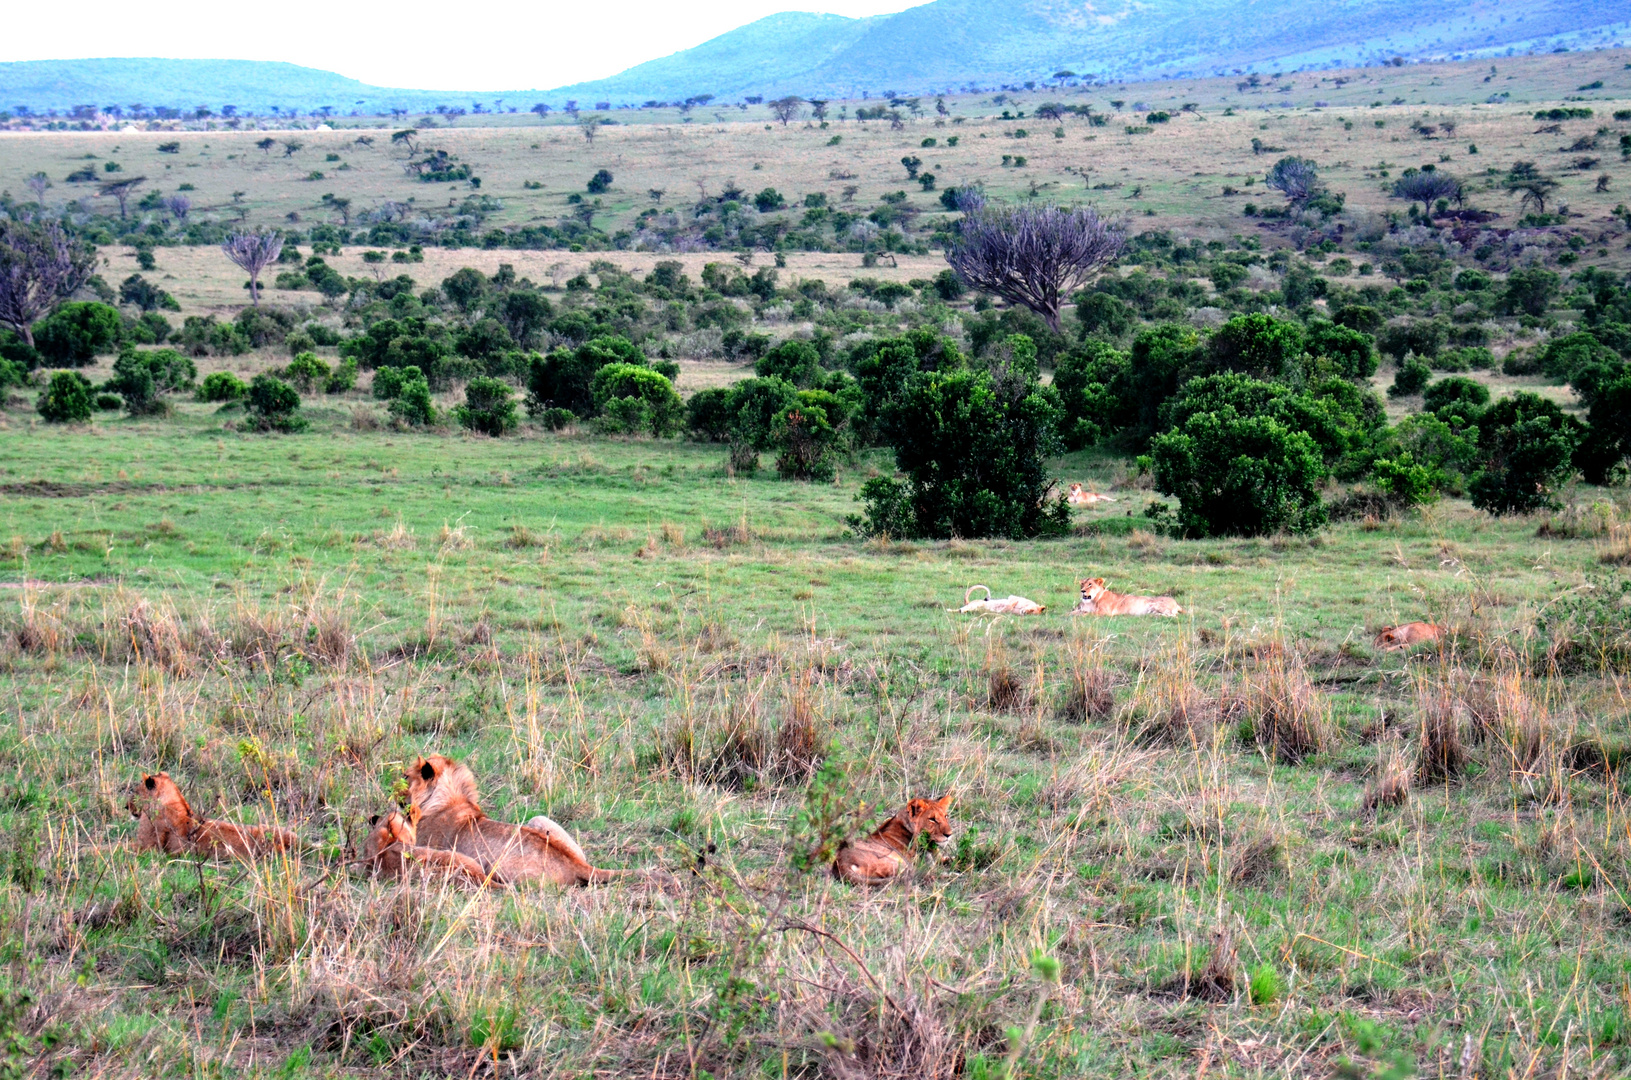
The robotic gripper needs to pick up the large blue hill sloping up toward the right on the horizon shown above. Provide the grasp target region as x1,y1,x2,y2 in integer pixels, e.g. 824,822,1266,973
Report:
548,0,1631,104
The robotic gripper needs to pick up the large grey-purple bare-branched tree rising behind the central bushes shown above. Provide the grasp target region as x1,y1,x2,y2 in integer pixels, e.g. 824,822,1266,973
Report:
946,193,1127,333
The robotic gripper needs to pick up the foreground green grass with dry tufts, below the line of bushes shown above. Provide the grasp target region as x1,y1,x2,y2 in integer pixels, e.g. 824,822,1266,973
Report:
0,405,1631,1077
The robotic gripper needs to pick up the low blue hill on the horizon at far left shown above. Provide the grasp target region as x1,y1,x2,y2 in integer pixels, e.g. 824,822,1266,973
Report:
0,59,541,116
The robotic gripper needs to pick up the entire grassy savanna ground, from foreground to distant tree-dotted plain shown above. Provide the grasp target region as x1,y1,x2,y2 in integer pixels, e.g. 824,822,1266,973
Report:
0,52,1631,1080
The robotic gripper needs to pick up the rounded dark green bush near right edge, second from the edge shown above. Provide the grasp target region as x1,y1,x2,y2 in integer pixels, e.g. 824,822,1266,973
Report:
1471,393,1584,514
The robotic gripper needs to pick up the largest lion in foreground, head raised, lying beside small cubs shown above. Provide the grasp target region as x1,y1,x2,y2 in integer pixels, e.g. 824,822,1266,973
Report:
406,754,674,887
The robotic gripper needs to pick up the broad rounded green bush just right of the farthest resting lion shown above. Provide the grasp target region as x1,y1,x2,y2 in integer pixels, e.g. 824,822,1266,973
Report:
1150,406,1326,537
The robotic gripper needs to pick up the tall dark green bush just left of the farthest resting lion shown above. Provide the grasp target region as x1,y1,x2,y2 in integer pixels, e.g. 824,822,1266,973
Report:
850,334,1070,540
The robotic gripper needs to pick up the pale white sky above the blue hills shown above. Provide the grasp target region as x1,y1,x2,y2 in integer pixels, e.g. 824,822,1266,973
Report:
0,0,925,90
